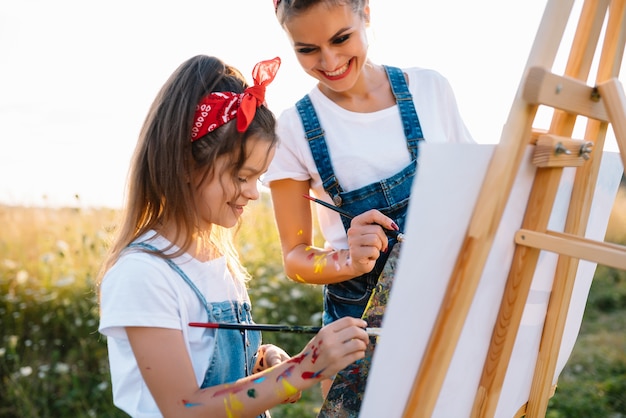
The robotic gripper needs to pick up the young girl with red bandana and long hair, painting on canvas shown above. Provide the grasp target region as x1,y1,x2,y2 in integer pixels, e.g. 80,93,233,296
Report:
99,56,368,417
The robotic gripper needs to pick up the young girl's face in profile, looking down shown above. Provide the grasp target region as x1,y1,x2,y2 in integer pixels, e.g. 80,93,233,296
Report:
195,137,275,230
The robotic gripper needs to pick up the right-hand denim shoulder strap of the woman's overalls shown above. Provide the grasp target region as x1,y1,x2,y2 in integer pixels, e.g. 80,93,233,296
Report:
383,65,424,160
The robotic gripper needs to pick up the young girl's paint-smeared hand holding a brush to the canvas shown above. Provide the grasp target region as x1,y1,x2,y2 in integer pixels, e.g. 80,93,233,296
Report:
290,317,369,380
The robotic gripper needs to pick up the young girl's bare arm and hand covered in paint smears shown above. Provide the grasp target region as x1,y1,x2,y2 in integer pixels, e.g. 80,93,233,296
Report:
126,317,368,418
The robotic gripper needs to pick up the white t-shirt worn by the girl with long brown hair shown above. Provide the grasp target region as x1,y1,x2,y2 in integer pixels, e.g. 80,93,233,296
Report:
99,235,249,418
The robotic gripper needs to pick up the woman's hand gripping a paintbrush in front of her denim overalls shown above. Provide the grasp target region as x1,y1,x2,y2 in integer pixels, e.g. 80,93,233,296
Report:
348,209,397,275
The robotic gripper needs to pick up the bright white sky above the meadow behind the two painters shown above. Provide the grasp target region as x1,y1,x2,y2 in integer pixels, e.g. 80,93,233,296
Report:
0,0,617,207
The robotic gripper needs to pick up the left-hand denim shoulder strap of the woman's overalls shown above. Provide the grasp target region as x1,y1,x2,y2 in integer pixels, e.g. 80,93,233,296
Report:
296,94,342,205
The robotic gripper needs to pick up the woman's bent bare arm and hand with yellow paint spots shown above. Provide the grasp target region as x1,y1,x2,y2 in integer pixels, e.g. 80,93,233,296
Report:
270,179,392,284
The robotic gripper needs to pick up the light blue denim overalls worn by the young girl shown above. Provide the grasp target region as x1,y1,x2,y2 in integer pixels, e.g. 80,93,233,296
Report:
129,242,269,418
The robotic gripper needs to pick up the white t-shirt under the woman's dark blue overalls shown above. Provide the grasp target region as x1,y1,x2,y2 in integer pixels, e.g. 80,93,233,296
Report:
263,68,474,249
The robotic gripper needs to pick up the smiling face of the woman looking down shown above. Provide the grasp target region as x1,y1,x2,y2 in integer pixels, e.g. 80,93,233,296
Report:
284,2,369,92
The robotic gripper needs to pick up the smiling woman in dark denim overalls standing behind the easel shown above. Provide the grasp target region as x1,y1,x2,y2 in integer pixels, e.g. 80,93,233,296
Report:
264,0,473,324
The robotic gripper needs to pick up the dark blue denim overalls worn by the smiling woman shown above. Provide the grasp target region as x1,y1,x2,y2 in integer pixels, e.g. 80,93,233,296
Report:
296,66,424,325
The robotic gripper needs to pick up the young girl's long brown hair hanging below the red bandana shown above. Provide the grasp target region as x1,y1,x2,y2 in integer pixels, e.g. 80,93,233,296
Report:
97,55,277,285
